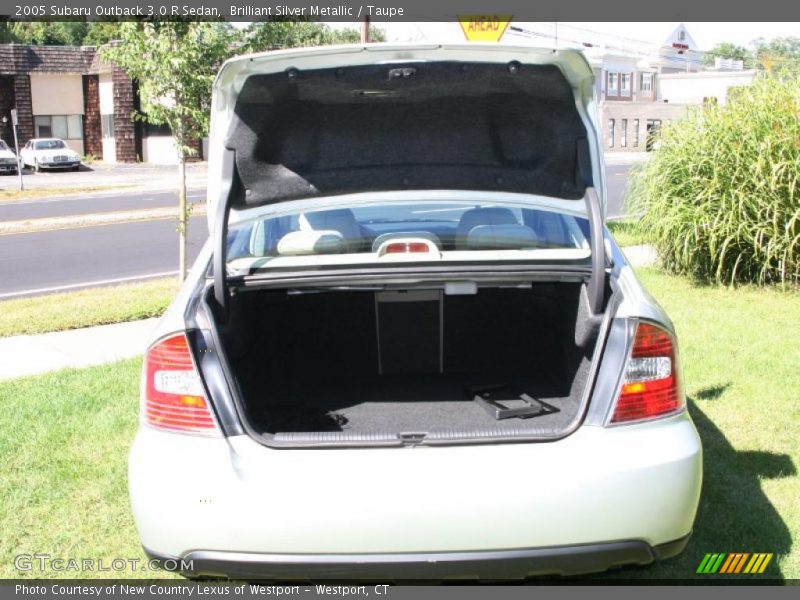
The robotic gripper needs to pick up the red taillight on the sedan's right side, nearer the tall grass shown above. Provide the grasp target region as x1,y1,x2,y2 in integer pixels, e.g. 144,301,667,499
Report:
611,322,684,423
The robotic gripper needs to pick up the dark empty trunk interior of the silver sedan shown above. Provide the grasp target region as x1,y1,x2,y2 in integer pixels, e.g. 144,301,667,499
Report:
220,283,598,443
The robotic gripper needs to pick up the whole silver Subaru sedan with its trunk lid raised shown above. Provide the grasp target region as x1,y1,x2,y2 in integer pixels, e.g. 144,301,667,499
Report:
130,45,701,580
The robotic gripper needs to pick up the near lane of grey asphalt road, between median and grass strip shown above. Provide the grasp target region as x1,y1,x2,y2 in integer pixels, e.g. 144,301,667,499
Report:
0,216,208,299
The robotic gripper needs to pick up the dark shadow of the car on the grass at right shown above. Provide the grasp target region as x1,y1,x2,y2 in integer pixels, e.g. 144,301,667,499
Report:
600,398,797,584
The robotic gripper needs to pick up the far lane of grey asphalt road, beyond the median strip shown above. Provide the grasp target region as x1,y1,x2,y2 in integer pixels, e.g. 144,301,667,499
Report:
0,190,205,221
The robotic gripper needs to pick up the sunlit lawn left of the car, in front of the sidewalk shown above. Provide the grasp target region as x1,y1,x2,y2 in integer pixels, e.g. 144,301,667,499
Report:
0,359,176,578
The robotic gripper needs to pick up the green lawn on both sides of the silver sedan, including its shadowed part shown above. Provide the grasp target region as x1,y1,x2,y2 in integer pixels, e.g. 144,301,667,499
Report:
0,268,800,581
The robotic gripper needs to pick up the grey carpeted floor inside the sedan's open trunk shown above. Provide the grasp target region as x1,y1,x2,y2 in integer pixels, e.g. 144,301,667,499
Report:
244,375,579,433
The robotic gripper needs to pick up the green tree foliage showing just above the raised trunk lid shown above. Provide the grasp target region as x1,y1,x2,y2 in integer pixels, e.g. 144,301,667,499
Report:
245,19,385,52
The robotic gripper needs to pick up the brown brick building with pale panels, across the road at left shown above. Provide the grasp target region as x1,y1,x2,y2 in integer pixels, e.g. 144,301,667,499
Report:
0,44,200,163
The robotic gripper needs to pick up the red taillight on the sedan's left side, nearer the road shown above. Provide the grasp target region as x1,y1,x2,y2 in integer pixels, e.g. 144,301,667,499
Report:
143,333,218,435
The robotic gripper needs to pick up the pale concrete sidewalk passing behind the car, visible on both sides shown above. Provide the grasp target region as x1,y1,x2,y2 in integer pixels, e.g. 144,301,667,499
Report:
0,246,656,381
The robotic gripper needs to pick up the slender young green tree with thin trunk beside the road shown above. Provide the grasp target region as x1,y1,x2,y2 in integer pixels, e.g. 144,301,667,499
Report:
101,21,234,281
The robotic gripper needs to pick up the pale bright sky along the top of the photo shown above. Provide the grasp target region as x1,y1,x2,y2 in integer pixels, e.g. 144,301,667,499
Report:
341,22,800,50
